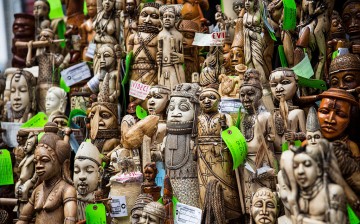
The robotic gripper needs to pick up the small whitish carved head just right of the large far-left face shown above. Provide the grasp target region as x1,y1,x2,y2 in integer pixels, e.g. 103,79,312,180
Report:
45,87,67,121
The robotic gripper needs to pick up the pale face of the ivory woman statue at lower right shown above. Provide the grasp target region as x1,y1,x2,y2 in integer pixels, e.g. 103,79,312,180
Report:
293,153,322,188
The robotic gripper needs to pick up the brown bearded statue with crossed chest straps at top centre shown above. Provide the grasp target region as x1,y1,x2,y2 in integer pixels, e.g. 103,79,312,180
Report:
127,3,161,93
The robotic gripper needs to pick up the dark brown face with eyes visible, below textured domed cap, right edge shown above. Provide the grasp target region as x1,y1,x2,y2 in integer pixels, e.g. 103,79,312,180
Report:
330,70,360,90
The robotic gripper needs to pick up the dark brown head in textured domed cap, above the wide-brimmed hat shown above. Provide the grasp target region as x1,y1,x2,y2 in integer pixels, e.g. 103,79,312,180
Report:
329,53,360,90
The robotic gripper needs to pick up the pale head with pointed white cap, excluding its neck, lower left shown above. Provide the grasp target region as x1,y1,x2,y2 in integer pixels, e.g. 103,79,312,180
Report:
74,142,102,197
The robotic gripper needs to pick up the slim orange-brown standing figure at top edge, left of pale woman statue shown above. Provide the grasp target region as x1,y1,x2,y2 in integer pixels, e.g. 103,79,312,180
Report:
79,0,97,61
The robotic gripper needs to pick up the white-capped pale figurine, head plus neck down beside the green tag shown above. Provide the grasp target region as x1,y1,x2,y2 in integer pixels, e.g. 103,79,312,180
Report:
74,142,102,221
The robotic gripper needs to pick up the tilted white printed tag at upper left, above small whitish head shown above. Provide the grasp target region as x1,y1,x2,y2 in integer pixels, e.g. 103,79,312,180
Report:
61,62,91,86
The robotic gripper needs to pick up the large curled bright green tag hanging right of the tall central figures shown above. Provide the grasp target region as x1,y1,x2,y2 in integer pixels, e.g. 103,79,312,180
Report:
221,126,247,170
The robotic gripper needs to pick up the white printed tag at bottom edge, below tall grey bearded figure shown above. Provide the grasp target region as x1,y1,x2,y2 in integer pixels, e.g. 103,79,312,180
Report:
175,202,202,224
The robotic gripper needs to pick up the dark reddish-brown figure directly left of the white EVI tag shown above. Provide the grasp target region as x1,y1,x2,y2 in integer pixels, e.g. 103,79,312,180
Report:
179,20,200,82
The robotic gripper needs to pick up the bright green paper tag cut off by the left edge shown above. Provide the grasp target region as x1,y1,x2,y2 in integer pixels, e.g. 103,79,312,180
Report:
0,149,14,186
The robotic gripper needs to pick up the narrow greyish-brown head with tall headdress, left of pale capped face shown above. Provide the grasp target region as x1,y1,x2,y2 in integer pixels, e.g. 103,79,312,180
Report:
240,69,262,114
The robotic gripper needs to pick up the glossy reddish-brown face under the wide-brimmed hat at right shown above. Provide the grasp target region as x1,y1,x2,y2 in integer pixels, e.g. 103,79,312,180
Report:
318,98,351,140
